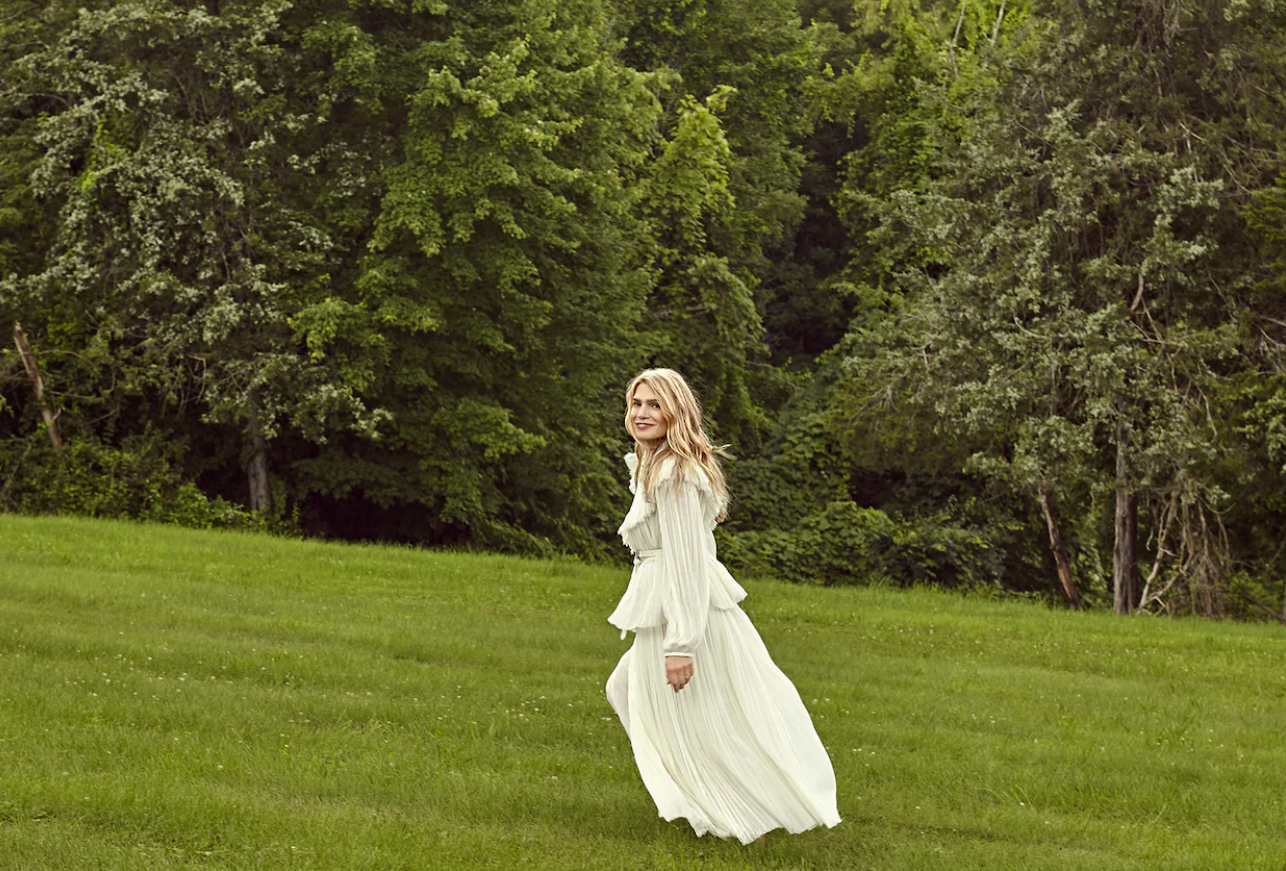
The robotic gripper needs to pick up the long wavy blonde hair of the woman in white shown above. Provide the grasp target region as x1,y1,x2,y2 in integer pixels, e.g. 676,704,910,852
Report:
625,369,728,520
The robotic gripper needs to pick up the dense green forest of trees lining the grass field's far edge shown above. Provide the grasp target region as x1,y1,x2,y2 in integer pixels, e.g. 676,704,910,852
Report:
0,0,1286,619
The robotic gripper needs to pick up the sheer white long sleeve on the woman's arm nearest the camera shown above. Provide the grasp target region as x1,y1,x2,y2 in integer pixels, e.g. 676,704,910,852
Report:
656,471,710,656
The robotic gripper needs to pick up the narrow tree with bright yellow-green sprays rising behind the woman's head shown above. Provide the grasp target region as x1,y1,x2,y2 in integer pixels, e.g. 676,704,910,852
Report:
617,0,822,434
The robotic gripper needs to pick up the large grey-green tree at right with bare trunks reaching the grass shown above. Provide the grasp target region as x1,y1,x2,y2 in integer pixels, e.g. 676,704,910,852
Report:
850,0,1281,612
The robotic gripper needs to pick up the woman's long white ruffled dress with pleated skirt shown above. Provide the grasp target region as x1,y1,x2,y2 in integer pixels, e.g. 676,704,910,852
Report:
607,454,840,844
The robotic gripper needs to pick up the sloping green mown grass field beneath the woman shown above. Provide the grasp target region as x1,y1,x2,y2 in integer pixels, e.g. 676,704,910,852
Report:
0,516,1286,871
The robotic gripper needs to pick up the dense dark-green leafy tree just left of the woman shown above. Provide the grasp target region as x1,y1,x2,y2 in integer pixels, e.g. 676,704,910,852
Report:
285,0,657,552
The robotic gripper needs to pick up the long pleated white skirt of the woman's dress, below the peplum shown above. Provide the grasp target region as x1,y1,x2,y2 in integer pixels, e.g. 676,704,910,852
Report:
607,606,840,844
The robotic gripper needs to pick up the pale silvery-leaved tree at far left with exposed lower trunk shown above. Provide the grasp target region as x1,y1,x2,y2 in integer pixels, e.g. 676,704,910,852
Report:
5,0,382,511
